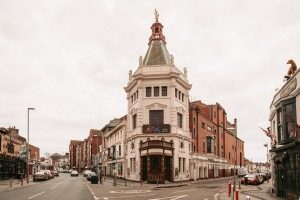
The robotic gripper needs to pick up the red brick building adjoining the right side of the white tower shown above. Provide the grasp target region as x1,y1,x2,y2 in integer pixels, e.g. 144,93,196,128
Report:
189,100,244,179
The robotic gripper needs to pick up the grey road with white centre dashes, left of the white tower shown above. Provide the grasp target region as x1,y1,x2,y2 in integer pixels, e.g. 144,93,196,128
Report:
0,174,94,200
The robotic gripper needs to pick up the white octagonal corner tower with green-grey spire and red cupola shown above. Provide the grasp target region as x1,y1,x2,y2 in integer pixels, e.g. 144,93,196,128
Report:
124,13,192,183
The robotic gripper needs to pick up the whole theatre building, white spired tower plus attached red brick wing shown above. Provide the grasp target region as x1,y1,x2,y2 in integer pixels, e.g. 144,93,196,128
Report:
124,13,244,183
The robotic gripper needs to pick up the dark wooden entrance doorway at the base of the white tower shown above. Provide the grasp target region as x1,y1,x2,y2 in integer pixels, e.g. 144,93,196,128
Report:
141,155,172,183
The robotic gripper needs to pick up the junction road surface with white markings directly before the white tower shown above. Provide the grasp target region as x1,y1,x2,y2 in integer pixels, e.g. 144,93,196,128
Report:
87,178,229,200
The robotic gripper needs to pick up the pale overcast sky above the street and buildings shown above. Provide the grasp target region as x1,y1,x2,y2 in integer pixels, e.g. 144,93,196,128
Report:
0,0,300,161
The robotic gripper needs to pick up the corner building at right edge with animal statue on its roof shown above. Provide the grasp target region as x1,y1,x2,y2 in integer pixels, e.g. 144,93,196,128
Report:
269,63,300,199
